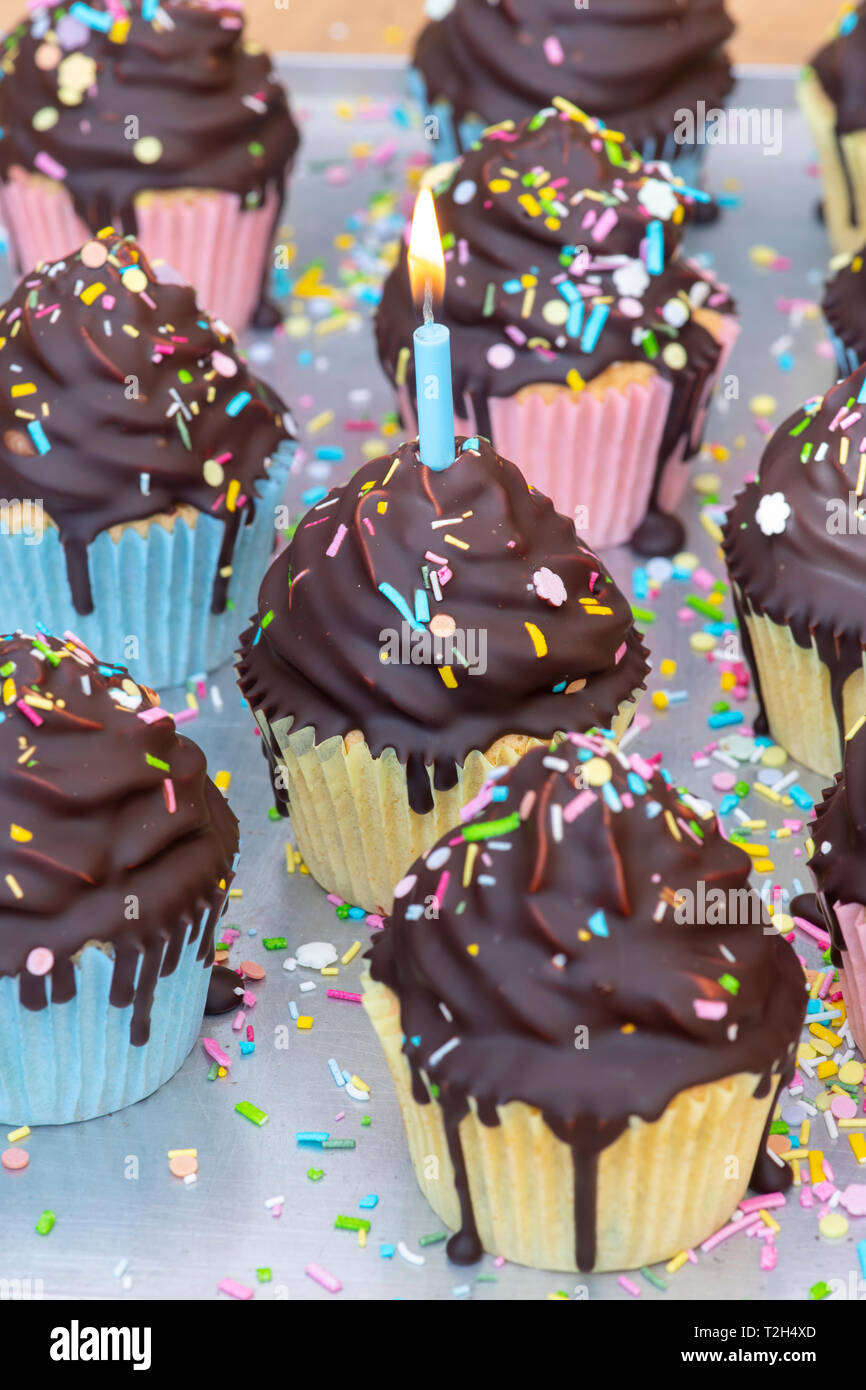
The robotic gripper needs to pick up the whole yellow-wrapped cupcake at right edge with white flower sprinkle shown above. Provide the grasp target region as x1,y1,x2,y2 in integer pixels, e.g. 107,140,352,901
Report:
723,367,866,777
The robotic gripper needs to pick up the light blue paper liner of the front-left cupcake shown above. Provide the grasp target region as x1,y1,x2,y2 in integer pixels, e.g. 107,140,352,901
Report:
0,923,210,1126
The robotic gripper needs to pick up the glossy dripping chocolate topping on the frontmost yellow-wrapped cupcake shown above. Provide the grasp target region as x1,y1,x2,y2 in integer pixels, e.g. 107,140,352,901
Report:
371,735,805,1269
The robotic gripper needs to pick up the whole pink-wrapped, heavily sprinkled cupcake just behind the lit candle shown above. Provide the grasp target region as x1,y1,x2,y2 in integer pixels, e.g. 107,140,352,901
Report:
377,97,737,555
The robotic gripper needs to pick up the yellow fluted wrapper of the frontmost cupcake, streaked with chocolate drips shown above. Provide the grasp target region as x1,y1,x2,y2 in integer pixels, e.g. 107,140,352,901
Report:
363,976,777,1272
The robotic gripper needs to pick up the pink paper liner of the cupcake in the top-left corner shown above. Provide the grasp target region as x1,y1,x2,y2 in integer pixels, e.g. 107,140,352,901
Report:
0,168,278,331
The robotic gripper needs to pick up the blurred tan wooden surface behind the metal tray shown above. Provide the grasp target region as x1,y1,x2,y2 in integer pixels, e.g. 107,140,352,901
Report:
0,0,844,63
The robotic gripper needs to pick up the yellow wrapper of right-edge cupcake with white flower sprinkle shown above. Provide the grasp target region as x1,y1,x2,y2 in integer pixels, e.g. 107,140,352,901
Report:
745,613,866,780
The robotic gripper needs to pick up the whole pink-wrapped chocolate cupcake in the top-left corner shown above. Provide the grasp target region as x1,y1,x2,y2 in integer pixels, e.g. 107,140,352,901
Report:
0,0,297,331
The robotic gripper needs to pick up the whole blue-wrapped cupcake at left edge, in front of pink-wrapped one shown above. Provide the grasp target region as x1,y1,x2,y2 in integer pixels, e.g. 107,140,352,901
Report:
0,233,293,685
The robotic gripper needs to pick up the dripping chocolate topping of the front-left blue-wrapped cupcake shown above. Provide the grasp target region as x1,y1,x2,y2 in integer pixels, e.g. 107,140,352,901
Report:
0,632,238,1047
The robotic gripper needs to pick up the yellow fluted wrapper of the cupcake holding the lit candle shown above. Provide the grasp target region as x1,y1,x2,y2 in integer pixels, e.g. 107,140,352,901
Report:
256,696,637,912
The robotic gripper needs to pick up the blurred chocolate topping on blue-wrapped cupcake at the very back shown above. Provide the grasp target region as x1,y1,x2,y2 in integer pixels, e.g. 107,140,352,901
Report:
414,0,734,149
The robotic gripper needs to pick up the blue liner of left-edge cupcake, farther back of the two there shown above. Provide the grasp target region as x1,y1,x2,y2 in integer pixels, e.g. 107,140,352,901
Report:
0,441,297,687
